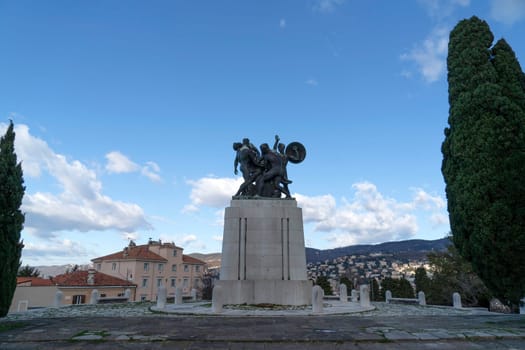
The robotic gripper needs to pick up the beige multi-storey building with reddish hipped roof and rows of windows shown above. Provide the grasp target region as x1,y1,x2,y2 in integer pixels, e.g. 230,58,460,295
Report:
91,240,206,301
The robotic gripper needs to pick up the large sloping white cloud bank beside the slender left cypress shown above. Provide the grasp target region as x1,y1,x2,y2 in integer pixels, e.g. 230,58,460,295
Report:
0,124,151,236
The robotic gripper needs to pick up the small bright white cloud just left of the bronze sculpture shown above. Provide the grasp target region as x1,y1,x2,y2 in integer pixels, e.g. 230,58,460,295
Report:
185,177,243,211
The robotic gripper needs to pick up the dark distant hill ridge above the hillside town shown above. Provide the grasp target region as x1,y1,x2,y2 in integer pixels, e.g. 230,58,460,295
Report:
306,238,452,263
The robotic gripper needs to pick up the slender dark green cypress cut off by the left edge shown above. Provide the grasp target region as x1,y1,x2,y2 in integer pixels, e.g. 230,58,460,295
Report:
0,122,25,317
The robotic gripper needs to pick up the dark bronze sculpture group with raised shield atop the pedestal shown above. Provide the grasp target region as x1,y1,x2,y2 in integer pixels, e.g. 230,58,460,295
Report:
233,135,306,199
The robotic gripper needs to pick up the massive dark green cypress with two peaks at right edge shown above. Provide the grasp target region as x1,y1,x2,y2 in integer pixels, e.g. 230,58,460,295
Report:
442,17,525,305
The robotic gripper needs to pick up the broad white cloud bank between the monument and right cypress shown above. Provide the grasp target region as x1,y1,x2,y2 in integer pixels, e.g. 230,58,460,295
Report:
295,182,448,246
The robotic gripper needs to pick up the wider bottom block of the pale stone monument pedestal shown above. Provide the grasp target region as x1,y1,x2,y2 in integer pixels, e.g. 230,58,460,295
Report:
215,280,312,306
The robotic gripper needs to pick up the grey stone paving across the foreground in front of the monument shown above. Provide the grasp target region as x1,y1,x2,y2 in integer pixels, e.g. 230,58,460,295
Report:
0,301,525,350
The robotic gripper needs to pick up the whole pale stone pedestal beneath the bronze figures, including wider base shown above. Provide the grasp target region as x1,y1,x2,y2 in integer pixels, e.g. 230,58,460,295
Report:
216,198,312,305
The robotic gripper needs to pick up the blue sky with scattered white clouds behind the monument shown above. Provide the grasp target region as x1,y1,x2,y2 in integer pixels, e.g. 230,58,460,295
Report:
0,0,525,265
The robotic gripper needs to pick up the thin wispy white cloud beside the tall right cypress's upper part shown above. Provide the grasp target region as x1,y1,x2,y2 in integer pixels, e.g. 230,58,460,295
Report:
401,27,449,83
